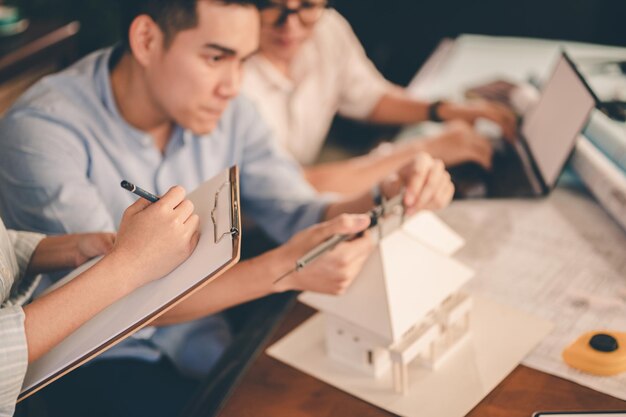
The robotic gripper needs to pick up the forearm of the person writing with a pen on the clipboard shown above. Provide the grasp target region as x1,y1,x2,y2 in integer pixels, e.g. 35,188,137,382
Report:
24,250,135,363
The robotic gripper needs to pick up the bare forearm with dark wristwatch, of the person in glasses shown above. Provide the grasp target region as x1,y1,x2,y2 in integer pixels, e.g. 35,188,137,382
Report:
367,91,429,125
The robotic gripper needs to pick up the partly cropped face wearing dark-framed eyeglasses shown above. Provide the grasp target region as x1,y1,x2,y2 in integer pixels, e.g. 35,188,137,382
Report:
261,0,326,61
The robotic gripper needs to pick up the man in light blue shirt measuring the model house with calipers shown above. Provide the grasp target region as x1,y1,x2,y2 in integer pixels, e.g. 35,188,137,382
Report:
0,0,453,415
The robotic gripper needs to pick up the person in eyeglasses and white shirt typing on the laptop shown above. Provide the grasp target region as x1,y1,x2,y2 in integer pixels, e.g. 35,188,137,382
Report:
242,0,515,194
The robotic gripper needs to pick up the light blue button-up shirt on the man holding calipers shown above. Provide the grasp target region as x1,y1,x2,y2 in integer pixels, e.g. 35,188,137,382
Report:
0,49,328,374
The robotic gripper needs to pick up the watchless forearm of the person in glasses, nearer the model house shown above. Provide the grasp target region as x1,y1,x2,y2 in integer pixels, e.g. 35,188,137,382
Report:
304,141,426,197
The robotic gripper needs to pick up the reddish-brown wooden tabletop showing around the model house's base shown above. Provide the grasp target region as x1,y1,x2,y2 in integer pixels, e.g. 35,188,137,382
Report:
210,303,626,417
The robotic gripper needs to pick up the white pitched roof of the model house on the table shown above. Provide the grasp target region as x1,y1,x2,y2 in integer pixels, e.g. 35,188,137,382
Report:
300,212,473,344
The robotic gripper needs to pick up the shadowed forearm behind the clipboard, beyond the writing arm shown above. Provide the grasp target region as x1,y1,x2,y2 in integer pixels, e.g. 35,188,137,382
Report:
28,235,84,274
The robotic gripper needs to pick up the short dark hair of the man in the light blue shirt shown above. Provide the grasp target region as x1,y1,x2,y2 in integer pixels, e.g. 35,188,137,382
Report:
120,0,267,50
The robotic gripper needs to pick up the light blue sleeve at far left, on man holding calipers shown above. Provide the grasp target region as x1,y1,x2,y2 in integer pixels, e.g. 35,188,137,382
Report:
0,110,115,234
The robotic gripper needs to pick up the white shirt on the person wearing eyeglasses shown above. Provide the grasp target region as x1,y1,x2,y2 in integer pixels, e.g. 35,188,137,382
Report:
242,9,392,165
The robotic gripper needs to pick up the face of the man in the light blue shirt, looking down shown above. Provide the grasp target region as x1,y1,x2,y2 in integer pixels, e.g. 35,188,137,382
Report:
145,0,260,134
